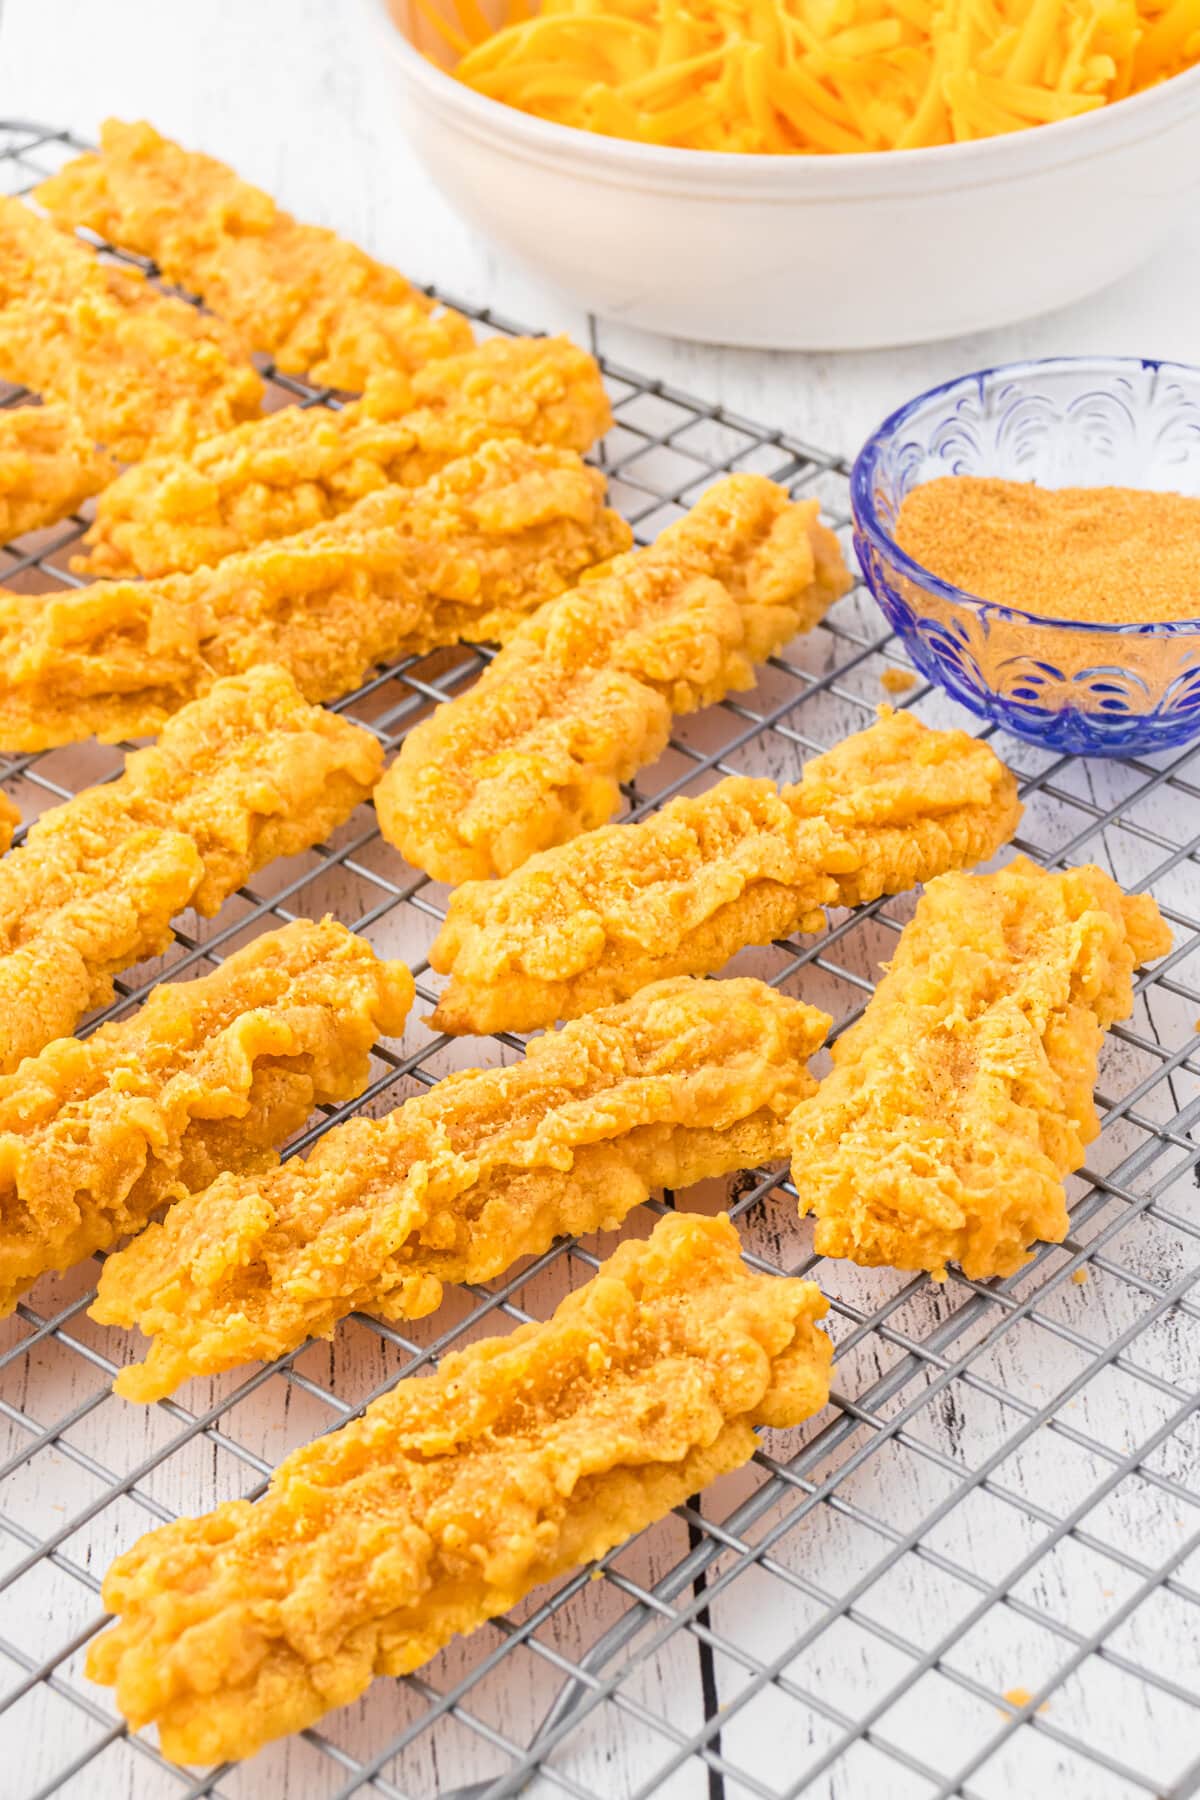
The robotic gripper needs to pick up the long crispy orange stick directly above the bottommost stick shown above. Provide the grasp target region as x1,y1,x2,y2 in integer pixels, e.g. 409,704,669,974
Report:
92,977,829,1400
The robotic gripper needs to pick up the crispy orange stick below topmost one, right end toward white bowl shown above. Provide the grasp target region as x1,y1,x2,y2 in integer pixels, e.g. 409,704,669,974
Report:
72,338,612,578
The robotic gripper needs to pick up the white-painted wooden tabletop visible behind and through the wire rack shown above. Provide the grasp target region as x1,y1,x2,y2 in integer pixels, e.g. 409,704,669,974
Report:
0,0,1200,1800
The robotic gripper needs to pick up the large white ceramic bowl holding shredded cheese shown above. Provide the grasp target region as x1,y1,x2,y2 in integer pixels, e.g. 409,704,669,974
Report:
360,0,1200,349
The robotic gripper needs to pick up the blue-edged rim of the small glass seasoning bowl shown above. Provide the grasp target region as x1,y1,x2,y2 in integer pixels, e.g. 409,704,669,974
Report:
849,355,1200,637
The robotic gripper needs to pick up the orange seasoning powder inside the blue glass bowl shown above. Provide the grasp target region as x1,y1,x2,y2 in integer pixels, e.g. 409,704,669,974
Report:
896,475,1200,625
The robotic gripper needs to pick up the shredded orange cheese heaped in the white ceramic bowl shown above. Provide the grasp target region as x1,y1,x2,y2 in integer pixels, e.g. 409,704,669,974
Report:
433,0,1200,153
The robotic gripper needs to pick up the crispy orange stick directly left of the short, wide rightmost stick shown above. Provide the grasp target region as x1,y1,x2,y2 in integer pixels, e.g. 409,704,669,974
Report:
430,707,1020,1031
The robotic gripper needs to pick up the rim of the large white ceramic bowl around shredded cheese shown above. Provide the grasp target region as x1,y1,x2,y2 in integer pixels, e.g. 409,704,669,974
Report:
360,0,1200,191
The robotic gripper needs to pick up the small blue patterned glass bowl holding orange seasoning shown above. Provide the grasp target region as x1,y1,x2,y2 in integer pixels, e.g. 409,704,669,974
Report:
851,356,1200,756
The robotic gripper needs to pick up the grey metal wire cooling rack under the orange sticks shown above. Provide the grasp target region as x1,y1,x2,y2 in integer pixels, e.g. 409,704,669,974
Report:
0,124,1200,1800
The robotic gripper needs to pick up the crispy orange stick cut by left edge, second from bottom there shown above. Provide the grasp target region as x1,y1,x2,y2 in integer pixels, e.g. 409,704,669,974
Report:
0,668,381,1073
